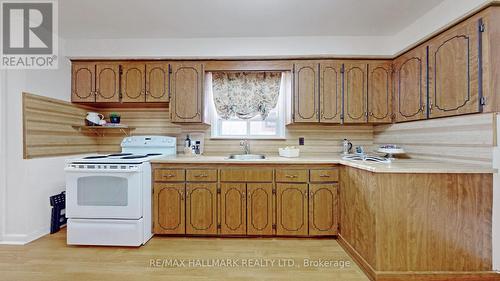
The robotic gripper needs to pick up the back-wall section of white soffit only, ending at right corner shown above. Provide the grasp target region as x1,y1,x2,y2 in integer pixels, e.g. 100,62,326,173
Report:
66,36,392,58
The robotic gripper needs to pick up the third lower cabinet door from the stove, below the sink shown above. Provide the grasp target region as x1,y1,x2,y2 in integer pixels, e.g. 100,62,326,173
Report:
220,183,247,235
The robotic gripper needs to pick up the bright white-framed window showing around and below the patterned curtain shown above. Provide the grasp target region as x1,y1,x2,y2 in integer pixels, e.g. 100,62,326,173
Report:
205,72,291,139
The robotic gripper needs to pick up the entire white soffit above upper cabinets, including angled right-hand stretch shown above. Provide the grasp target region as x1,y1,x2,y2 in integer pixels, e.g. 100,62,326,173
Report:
66,0,491,58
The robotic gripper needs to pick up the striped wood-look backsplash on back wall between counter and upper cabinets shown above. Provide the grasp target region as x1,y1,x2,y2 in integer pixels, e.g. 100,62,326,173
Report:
99,108,373,155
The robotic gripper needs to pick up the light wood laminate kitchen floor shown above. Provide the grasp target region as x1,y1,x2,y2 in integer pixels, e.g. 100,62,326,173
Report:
0,230,368,281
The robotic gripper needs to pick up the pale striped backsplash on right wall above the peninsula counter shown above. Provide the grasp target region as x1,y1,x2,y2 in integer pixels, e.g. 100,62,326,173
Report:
373,113,496,166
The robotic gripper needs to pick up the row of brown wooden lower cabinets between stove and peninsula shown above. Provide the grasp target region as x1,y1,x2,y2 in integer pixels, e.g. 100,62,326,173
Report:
152,164,339,236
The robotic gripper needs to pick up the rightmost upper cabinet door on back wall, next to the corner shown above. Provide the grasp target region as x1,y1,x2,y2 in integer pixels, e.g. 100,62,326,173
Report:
368,62,392,123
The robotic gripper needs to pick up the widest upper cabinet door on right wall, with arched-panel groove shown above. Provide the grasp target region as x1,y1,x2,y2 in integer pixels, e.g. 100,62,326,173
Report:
429,16,480,118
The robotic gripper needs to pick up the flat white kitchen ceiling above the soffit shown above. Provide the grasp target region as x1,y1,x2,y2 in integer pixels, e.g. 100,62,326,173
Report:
59,0,443,39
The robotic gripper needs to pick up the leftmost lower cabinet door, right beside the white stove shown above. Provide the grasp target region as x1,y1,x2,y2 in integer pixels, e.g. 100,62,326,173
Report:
153,183,186,234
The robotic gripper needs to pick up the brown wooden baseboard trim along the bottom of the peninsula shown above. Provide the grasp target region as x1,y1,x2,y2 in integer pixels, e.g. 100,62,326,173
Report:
337,234,500,281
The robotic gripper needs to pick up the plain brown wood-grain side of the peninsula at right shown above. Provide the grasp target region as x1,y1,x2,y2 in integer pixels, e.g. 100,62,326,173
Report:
339,166,498,280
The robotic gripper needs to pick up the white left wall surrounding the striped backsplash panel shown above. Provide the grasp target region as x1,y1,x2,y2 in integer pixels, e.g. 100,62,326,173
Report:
2,41,71,243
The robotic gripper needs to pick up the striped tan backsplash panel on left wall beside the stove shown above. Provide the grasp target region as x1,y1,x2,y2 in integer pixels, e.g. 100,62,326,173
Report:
23,93,98,159
